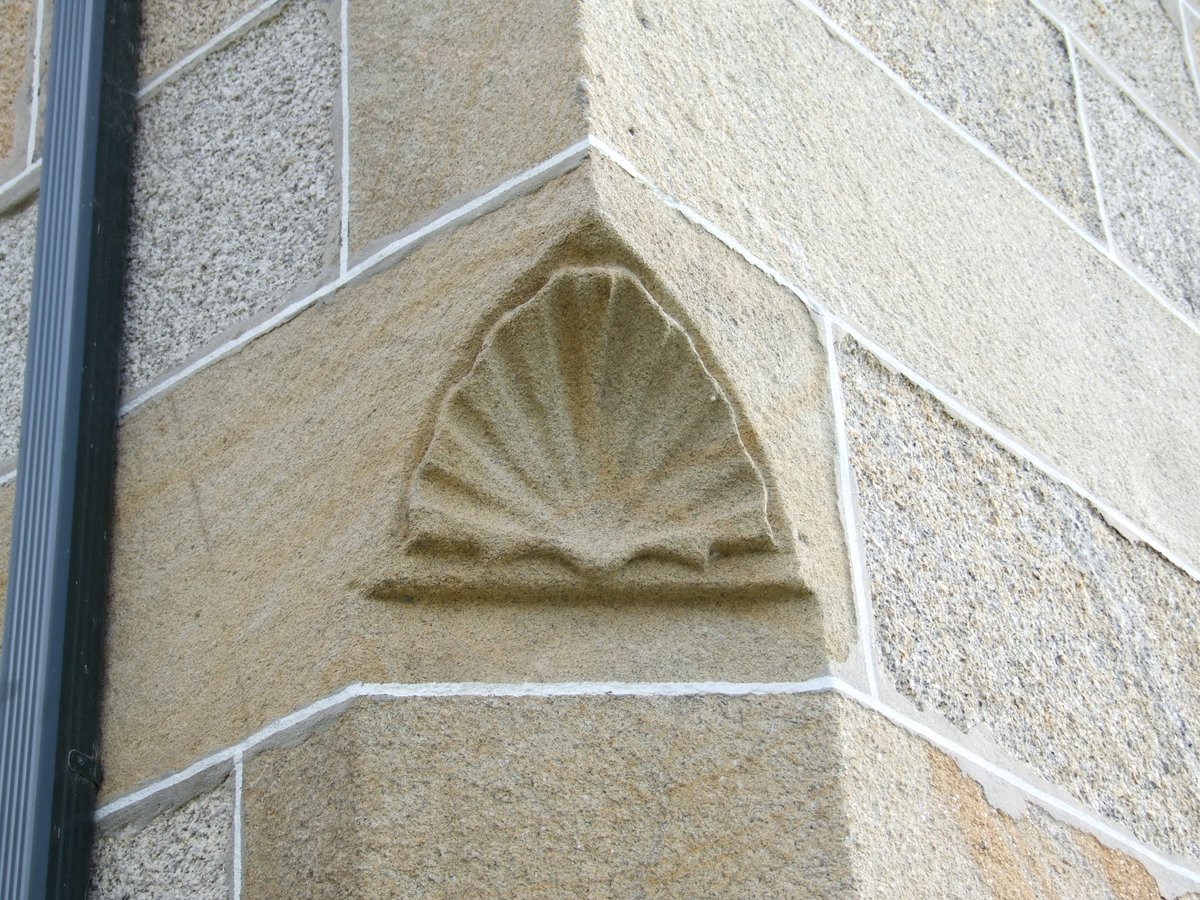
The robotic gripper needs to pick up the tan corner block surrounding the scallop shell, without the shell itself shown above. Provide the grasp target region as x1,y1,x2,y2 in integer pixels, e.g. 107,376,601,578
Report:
103,164,853,796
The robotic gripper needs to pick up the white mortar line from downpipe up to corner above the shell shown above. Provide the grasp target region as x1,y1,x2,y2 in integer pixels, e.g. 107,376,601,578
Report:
119,139,590,418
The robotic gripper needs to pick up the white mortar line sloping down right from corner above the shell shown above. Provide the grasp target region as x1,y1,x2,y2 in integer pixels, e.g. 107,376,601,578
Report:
592,138,1200,581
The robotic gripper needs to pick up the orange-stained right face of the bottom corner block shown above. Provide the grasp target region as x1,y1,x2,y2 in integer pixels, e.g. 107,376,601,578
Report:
840,703,1159,900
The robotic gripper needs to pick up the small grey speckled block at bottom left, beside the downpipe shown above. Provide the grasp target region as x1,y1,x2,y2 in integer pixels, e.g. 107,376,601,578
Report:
88,781,232,900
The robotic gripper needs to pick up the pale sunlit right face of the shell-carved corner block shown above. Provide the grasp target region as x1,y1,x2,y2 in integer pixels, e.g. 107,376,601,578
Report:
590,161,856,678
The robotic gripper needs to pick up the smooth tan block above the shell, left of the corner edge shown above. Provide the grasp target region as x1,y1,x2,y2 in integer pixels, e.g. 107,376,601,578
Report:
349,0,587,251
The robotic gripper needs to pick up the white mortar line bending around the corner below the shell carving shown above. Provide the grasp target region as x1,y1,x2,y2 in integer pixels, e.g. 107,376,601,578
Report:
95,676,1200,884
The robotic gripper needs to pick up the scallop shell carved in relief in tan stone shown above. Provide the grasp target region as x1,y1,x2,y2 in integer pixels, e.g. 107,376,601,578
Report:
408,269,775,576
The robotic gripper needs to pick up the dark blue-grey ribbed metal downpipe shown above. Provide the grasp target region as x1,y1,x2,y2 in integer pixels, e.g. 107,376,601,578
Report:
0,0,138,898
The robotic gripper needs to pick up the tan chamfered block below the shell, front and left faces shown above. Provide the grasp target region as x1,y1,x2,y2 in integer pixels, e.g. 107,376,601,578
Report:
244,697,853,896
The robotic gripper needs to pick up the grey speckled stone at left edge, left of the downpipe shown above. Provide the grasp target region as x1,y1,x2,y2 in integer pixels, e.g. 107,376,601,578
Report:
0,198,37,472
